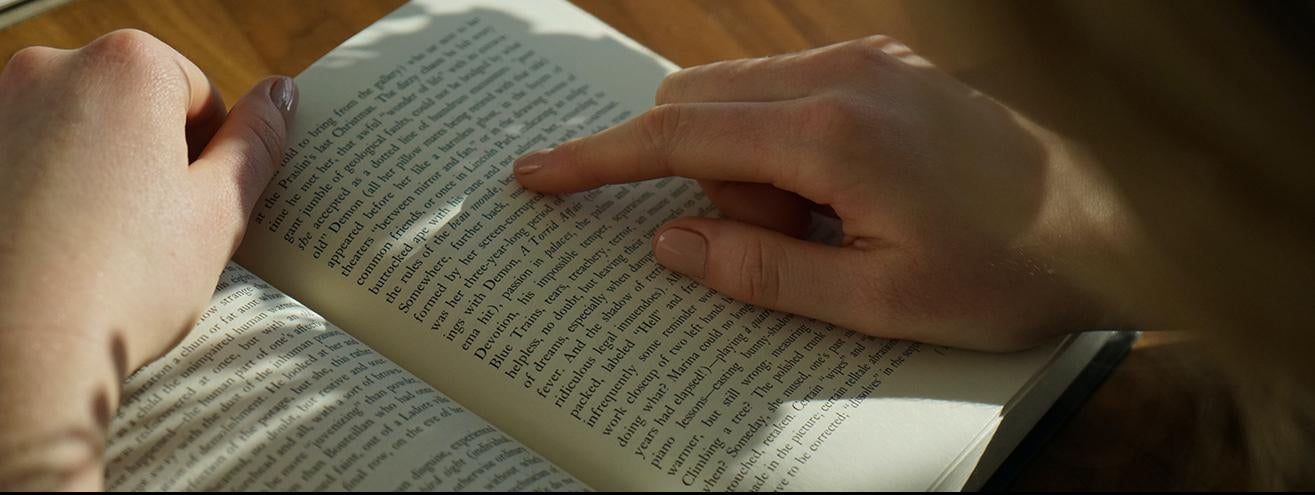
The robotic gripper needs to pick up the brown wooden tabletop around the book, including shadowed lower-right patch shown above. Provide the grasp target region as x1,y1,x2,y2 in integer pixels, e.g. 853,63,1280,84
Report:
0,0,1236,490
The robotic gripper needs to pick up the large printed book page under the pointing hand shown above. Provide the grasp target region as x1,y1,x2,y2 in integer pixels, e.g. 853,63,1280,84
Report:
239,0,1055,490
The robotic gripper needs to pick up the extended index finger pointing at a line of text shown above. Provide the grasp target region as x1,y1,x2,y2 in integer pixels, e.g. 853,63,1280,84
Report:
515,103,831,203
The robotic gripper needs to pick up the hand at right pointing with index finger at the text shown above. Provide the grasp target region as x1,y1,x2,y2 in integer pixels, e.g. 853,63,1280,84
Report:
515,37,1118,350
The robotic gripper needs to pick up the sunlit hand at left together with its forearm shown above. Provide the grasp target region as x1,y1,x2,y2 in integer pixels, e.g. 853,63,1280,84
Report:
0,30,296,488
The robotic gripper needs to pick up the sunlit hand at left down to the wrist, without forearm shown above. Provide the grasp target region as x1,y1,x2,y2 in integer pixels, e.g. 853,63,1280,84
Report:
0,30,296,371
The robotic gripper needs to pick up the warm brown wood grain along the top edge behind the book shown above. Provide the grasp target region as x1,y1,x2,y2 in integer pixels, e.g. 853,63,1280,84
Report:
0,0,1041,101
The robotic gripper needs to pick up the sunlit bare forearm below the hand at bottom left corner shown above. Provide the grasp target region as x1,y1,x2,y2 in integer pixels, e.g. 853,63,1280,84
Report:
0,326,126,491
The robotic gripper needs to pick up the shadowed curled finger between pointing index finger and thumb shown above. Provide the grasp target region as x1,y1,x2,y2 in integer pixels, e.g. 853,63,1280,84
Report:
700,180,813,237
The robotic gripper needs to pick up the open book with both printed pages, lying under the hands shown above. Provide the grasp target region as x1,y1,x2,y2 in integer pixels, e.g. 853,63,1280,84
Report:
107,0,1106,490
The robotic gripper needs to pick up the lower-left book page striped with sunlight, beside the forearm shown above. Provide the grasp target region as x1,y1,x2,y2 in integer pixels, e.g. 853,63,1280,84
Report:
105,265,584,491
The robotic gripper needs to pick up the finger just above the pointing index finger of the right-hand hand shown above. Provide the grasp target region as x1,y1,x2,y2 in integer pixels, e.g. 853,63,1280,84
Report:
655,36,926,104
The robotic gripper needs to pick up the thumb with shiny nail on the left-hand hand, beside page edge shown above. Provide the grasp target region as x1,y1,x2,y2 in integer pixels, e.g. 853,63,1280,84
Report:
192,76,297,249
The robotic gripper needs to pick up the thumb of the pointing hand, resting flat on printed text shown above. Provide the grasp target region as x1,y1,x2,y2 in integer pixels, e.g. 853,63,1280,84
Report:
654,217,867,325
